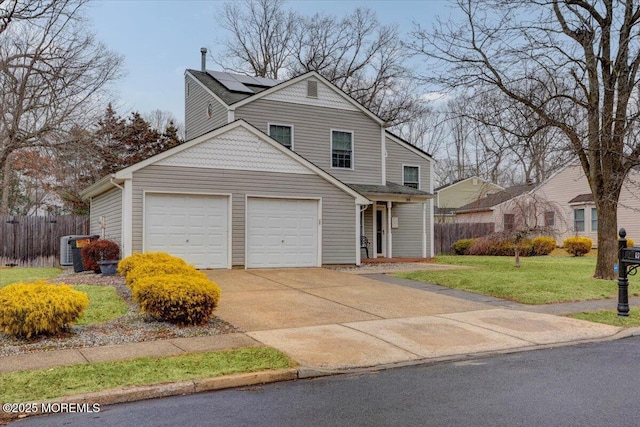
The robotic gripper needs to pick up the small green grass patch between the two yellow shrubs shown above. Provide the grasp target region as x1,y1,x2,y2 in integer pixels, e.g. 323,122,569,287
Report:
73,285,129,326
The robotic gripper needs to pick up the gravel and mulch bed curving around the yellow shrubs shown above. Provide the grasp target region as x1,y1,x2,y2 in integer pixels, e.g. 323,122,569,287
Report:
0,271,241,356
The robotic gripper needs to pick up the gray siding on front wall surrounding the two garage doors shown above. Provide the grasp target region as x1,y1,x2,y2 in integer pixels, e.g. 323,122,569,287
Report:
133,165,356,266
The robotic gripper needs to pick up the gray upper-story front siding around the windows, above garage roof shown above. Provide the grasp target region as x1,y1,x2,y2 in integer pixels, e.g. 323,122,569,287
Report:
235,99,382,184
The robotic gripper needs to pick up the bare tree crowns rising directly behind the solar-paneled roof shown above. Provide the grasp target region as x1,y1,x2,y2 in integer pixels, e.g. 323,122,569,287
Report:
212,0,425,125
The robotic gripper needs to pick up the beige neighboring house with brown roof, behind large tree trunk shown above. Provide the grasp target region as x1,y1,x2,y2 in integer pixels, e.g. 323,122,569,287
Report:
456,161,640,246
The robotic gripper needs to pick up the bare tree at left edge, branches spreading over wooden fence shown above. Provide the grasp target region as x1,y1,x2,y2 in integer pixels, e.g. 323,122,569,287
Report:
0,0,122,213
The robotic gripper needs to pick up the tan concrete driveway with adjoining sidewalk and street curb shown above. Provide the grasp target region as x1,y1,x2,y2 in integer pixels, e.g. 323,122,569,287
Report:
0,269,640,419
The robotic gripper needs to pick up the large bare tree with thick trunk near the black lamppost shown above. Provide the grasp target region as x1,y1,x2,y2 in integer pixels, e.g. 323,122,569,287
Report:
413,0,640,279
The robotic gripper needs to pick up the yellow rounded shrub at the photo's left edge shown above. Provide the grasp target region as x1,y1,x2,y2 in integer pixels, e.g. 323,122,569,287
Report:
0,280,89,338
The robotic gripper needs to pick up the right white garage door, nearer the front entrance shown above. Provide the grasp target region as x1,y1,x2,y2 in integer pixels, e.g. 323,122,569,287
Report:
247,198,319,268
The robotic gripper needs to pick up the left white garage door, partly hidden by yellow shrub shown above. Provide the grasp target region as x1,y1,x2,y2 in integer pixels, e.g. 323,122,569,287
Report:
144,193,229,268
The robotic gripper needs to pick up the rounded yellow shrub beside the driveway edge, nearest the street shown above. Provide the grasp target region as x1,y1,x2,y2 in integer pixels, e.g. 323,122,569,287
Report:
133,276,220,325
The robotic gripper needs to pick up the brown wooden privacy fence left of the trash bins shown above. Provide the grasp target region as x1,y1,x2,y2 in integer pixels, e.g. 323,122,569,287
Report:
0,216,89,267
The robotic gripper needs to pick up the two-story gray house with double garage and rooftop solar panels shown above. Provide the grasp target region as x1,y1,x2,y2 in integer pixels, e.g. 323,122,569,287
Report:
83,51,433,268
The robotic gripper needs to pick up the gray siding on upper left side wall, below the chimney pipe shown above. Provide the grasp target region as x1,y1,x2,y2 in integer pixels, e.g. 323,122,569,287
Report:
184,75,228,141
